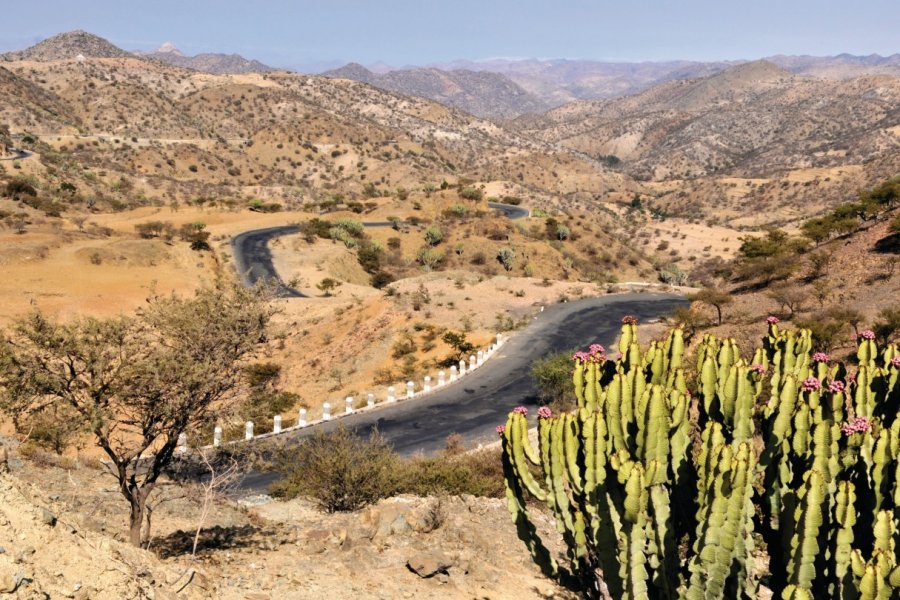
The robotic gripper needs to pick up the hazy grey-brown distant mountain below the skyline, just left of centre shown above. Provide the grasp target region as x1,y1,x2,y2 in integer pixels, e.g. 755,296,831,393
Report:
322,63,549,119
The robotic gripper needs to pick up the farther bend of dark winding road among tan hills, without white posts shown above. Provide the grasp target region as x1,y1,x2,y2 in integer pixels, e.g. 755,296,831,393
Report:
231,202,529,298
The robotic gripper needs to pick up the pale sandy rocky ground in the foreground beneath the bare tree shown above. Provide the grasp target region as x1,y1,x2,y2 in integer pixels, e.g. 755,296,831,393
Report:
0,442,571,600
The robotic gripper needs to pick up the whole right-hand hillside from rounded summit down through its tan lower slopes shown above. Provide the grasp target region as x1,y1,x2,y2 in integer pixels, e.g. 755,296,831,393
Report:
515,61,900,225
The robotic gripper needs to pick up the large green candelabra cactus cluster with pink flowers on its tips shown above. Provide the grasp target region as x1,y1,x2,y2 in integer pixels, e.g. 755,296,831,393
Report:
498,318,900,600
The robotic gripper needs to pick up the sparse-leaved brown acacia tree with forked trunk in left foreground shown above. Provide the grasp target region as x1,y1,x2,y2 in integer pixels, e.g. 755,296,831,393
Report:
0,285,273,546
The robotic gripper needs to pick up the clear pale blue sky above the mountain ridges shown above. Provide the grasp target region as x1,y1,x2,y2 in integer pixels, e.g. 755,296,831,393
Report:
0,0,900,68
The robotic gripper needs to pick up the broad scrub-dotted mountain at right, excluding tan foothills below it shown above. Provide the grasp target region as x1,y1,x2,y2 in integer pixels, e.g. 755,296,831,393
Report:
515,61,900,180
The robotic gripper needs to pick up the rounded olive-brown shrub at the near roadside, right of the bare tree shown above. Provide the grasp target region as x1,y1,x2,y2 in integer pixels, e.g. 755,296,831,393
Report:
271,425,398,512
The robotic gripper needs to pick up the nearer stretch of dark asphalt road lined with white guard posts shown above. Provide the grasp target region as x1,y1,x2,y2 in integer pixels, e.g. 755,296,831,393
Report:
242,293,687,495
